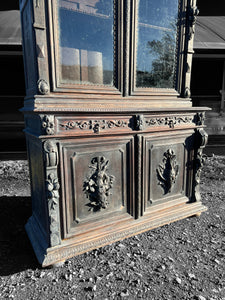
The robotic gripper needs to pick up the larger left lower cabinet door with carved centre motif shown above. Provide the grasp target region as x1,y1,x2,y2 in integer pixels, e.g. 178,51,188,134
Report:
60,136,134,237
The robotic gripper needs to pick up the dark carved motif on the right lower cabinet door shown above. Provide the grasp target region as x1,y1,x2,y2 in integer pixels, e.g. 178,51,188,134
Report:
156,149,179,194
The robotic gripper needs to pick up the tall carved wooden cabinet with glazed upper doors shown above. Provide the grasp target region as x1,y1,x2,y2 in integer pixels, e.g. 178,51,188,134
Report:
20,0,207,266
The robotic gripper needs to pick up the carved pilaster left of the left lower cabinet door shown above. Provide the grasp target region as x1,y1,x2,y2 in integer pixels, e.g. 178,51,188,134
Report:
43,140,61,247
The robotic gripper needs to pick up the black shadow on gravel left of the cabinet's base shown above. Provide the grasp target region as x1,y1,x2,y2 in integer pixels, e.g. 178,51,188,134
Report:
0,197,39,276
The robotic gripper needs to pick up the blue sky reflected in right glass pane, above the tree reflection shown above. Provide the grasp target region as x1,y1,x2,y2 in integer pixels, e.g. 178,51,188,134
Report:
136,0,179,87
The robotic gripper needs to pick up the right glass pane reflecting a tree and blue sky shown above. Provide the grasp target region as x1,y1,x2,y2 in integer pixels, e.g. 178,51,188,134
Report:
136,0,179,88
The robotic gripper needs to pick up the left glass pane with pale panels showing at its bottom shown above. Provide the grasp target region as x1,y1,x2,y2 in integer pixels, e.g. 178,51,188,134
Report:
58,0,114,85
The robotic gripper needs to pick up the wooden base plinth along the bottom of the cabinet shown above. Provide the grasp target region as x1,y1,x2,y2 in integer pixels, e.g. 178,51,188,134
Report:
26,202,207,267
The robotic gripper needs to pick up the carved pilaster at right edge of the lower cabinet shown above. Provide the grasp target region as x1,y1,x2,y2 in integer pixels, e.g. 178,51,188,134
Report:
192,128,208,202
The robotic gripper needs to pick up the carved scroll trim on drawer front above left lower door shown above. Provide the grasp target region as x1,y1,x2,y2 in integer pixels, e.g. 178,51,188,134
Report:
59,120,128,133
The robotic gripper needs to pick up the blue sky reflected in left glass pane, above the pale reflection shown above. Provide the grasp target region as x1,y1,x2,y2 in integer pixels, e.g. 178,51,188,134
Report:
58,0,114,83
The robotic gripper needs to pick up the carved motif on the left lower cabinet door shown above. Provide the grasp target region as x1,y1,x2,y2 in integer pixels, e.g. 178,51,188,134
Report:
84,156,115,212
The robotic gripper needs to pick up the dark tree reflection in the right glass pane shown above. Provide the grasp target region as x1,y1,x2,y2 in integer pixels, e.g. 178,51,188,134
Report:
136,25,176,88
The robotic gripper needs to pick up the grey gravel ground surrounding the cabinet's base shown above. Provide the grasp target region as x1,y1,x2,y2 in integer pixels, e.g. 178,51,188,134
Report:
0,156,225,300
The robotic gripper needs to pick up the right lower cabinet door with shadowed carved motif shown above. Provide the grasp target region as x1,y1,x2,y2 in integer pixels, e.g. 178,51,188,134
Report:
142,131,194,210
